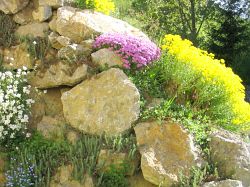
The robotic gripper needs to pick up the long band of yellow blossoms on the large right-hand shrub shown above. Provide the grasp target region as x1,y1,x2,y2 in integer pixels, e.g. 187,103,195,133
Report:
162,35,250,129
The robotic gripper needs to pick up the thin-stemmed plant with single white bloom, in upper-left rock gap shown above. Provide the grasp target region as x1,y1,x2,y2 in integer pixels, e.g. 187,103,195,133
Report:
20,36,51,62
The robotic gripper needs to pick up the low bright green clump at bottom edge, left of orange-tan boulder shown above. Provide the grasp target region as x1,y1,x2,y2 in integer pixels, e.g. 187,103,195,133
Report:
99,163,129,187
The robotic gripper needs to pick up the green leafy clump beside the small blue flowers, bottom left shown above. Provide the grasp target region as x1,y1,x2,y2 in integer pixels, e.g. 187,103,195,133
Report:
9,134,69,187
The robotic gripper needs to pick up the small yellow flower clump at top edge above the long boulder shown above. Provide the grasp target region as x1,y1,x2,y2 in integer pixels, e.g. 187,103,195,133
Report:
86,0,115,15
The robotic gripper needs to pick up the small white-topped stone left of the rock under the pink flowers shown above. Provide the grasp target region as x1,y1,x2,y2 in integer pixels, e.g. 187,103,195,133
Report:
57,44,91,63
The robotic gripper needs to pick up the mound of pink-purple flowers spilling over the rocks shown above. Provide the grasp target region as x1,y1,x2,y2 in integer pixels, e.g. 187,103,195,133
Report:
94,33,161,69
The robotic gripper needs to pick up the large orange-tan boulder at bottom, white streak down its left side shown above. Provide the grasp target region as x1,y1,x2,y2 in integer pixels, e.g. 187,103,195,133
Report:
134,121,201,187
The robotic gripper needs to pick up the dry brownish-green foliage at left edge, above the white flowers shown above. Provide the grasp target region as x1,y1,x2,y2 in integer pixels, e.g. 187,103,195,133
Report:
0,12,16,47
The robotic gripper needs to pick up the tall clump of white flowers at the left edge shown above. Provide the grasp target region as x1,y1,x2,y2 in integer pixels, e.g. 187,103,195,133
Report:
0,67,34,146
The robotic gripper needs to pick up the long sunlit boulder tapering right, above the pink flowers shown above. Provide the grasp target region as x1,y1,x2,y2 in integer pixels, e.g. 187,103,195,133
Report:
56,7,148,43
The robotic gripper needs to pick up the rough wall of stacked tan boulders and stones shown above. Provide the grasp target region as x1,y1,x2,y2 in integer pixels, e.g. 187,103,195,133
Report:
0,0,250,187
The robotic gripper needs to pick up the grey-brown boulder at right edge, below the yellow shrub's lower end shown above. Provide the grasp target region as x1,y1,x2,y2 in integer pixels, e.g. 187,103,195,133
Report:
209,130,250,186
